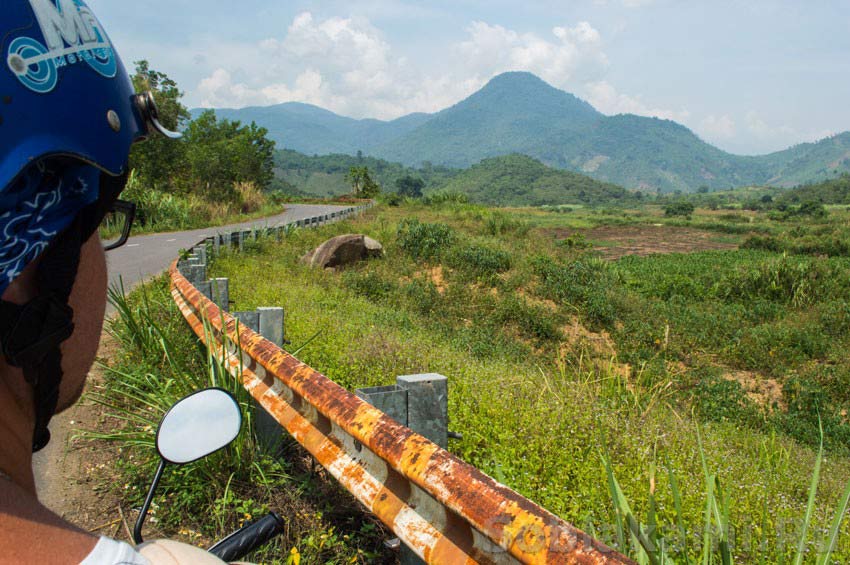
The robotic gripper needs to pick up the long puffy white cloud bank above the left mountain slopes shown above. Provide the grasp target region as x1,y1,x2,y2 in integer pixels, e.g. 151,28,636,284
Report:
194,12,608,119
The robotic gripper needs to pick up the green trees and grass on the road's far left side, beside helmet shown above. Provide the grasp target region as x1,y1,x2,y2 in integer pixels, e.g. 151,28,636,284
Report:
122,61,286,233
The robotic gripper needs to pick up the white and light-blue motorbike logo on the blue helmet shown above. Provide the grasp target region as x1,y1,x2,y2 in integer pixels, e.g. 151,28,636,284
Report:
6,0,117,93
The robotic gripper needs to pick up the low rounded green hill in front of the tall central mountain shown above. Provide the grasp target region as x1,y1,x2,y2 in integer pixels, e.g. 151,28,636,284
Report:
442,154,636,206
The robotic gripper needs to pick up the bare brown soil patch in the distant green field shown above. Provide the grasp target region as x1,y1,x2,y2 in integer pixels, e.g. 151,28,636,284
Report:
553,225,738,261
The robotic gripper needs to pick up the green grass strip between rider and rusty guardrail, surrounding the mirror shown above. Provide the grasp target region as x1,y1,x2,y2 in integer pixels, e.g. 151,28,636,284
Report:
83,276,387,564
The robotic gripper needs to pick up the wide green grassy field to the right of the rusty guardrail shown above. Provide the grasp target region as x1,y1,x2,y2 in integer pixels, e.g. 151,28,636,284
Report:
204,205,850,562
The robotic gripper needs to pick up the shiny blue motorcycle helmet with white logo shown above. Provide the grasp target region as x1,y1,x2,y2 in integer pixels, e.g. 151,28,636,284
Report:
0,0,147,188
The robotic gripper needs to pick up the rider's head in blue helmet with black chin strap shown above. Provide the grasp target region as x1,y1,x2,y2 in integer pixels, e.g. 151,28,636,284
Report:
0,0,173,450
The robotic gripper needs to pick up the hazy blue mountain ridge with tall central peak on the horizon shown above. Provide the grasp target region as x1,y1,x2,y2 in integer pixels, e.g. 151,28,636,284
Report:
192,72,850,192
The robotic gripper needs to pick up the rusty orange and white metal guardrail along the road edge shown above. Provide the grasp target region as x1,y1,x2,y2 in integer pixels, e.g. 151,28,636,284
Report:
170,208,632,564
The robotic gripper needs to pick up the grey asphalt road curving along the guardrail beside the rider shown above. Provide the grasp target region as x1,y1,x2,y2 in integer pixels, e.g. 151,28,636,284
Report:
33,204,347,515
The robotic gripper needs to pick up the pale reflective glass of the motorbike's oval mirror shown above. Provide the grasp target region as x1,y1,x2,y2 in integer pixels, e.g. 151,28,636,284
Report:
156,388,242,465
